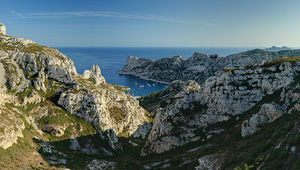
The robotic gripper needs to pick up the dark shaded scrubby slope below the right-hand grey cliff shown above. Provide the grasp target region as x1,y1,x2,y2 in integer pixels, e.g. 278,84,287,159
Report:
136,78,300,170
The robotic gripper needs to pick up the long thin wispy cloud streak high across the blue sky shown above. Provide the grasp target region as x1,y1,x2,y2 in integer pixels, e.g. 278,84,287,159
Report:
11,11,212,25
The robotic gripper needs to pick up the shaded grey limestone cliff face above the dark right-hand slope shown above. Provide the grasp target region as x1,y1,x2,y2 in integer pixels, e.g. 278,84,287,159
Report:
143,58,300,154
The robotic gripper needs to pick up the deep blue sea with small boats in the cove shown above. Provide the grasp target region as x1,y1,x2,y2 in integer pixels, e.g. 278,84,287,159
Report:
57,47,253,96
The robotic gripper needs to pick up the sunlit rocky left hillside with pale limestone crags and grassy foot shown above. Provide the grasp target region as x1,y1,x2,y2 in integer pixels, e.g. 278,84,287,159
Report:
0,34,151,169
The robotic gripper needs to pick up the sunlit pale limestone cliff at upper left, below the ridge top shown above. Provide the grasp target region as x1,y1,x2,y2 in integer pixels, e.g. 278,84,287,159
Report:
0,33,77,92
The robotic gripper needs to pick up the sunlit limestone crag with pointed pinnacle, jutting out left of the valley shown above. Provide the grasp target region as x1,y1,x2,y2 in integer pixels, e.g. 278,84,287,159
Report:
58,66,149,136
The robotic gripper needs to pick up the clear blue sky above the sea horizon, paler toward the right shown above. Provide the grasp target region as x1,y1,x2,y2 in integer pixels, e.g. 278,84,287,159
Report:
0,0,300,47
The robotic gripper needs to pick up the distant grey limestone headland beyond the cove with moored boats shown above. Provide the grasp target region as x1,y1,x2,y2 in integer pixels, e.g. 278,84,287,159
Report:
120,49,300,84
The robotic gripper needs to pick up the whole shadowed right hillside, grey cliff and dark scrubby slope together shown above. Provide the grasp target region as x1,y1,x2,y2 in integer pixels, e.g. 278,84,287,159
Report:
140,57,300,169
